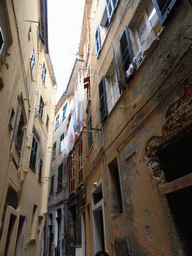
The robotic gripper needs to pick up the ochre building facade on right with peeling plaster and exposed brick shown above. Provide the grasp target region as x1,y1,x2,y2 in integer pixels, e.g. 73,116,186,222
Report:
62,0,192,256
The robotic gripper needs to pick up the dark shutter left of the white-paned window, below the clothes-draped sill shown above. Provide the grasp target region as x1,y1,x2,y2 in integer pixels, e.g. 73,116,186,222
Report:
99,77,108,122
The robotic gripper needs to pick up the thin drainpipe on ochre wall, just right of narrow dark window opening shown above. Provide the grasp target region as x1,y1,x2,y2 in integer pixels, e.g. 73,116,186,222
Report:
116,148,132,256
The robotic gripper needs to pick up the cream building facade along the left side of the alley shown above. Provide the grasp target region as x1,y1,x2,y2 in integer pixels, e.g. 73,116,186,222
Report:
0,0,56,256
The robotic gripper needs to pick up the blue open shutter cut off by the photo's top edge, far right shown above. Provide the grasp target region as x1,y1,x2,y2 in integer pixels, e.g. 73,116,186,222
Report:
152,0,177,25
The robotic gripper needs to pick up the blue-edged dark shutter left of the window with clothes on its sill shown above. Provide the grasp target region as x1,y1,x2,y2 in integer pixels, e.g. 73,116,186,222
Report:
119,27,133,82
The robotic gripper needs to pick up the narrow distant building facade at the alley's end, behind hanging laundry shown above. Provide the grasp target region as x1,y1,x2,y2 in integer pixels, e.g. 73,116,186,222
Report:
44,58,83,256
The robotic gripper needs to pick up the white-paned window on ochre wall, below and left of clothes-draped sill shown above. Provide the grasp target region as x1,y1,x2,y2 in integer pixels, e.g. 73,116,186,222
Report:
105,63,120,112
